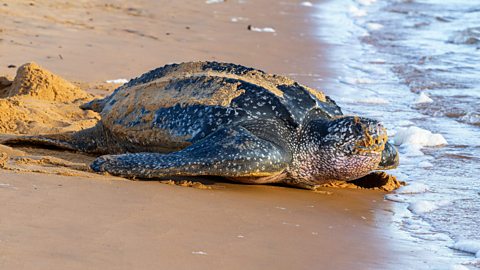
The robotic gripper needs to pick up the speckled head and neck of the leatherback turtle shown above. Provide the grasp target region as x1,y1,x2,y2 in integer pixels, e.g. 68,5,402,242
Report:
292,116,392,184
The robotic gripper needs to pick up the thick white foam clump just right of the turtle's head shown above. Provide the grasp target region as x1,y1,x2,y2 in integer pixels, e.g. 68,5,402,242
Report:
393,126,448,147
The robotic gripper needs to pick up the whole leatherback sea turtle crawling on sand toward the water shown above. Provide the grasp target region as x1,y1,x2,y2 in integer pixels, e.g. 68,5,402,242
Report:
7,62,398,188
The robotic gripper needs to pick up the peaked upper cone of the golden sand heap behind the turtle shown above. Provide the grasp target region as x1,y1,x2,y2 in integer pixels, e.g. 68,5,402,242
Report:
4,63,91,102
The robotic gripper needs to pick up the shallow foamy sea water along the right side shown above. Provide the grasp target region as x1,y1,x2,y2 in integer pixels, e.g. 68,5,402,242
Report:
315,0,480,269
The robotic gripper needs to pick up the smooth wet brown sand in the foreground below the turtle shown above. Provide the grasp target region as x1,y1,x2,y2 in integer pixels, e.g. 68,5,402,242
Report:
0,172,404,269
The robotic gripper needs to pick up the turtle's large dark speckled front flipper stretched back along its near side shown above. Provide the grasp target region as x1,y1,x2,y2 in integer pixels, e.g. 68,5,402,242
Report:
90,126,291,184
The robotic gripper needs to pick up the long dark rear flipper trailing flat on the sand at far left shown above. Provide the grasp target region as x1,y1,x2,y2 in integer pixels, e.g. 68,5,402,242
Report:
2,125,105,153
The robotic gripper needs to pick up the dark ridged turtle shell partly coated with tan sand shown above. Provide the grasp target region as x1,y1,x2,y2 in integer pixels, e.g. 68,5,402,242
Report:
95,62,342,152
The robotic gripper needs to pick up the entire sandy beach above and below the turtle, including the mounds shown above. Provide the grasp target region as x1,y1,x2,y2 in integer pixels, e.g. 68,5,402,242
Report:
0,0,409,269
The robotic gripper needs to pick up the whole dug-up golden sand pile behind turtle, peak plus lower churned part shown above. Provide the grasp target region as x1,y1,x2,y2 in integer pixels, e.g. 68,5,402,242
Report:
0,63,100,135
